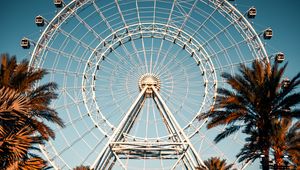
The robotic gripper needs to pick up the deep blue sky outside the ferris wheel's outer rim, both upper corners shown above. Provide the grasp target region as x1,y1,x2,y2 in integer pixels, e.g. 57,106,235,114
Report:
0,0,300,170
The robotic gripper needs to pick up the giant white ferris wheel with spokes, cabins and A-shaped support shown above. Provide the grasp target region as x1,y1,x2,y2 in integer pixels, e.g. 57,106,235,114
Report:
21,0,278,169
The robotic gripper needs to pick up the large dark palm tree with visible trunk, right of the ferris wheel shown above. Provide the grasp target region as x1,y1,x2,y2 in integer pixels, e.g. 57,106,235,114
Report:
199,60,300,170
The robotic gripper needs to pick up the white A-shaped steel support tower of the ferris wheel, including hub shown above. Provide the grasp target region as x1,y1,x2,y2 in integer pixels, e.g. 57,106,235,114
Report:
92,74,205,170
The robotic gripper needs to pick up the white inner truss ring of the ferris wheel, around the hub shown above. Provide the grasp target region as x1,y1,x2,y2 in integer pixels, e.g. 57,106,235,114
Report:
82,22,217,137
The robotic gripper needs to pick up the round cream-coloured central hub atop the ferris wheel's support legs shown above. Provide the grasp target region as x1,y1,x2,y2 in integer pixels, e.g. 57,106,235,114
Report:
139,73,160,97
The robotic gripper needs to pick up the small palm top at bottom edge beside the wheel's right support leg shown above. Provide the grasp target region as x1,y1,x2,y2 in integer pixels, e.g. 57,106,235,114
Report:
196,157,233,170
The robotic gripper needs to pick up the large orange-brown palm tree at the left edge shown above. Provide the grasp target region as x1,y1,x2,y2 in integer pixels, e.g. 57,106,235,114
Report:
0,54,64,169
